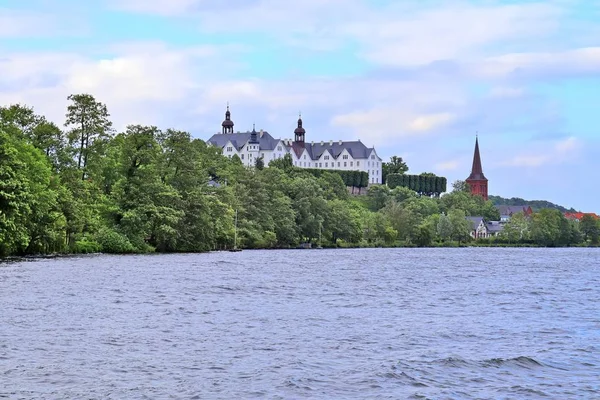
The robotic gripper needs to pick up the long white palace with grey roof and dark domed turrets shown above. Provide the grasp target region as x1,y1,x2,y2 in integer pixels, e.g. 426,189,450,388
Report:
208,106,381,184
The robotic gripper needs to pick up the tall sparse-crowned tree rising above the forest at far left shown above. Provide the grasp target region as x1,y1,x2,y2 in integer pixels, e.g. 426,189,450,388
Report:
65,94,112,179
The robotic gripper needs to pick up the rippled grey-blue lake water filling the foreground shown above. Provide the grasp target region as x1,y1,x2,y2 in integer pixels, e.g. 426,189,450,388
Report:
0,249,600,399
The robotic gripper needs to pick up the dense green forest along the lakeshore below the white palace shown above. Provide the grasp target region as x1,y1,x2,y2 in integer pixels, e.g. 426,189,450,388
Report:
0,94,600,257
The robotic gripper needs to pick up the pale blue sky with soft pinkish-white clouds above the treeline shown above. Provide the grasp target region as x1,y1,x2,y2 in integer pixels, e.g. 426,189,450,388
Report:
0,0,600,213
